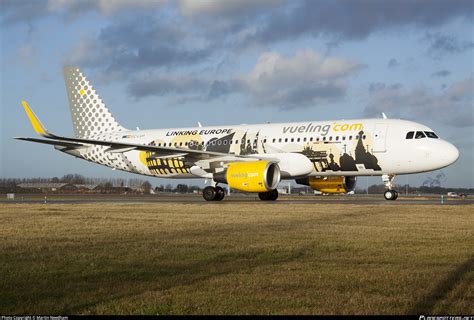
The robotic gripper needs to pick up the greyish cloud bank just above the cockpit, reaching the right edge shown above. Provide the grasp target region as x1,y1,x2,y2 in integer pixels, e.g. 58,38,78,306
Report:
364,78,474,127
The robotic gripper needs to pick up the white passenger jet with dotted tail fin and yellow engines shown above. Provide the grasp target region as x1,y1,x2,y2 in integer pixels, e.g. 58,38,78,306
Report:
15,67,459,201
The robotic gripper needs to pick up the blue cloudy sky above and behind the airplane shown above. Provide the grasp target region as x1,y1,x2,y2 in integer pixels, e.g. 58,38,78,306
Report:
0,0,474,188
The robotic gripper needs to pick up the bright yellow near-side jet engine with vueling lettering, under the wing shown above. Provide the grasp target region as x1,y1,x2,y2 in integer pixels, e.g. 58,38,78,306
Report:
214,160,280,192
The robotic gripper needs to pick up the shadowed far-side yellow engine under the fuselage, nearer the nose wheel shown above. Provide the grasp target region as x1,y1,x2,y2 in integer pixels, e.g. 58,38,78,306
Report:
296,176,357,193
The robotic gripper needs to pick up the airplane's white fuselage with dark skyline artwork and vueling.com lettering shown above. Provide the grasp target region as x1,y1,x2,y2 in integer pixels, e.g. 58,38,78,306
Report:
63,119,459,179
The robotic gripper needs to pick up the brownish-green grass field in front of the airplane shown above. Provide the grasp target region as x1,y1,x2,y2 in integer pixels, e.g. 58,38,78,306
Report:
0,202,474,314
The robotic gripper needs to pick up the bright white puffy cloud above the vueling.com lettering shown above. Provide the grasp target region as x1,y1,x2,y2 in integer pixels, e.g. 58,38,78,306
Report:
240,49,362,108
